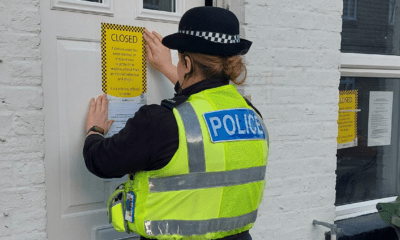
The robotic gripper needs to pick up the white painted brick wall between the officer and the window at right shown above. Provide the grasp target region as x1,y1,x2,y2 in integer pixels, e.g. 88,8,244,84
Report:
239,0,343,240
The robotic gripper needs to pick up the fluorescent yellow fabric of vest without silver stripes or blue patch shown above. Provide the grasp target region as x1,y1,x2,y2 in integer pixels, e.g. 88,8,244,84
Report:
126,85,268,240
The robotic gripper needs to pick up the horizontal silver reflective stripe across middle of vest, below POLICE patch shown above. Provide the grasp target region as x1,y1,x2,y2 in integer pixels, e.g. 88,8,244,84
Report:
149,166,266,192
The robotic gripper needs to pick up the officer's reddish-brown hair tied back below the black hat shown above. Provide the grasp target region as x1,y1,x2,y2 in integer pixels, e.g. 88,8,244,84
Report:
179,51,247,85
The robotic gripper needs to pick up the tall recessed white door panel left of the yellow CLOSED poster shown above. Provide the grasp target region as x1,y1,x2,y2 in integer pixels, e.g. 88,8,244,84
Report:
57,39,105,216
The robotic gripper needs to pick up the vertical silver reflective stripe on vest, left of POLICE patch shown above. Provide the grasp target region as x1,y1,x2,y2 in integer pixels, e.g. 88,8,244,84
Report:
176,102,206,173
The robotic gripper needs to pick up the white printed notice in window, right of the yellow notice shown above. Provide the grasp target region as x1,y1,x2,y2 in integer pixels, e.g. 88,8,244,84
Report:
368,92,393,147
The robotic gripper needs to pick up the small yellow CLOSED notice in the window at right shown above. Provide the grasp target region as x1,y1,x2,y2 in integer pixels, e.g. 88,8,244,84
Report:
337,90,359,149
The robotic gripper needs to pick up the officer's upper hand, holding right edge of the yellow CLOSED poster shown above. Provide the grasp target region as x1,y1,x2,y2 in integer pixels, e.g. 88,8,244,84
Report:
143,29,178,84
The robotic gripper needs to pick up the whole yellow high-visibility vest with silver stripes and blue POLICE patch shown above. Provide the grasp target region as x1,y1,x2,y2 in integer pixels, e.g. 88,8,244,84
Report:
125,85,268,240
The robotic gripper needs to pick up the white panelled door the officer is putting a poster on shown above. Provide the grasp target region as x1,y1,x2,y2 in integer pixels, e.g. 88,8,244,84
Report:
40,0,204,240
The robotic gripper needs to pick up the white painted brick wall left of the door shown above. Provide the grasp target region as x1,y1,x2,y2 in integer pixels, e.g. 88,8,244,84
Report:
0,0,47,240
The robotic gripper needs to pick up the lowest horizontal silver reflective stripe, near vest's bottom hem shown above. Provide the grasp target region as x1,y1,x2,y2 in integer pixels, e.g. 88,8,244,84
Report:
144,210,257,236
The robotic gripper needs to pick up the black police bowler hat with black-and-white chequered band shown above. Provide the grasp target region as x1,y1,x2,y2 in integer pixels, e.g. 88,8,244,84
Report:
162,7,251,56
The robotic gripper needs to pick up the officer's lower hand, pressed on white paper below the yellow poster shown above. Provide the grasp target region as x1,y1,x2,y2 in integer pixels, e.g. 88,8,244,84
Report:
85,93,114,134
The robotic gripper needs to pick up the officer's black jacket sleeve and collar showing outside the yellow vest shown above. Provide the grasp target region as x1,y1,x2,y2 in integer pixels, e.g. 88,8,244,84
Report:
83,79,261,240
